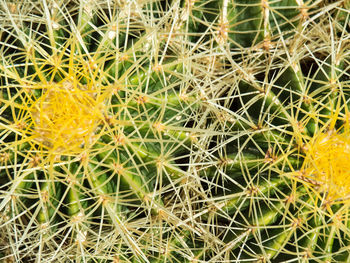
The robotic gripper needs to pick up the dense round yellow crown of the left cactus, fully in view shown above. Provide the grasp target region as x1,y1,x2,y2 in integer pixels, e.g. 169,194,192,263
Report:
29,80,104,154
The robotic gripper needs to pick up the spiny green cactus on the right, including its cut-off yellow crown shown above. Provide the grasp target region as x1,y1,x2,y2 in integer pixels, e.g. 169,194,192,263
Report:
208,5,350,262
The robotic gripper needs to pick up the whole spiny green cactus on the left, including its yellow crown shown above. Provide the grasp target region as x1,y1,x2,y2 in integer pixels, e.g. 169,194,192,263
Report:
0,1,221,262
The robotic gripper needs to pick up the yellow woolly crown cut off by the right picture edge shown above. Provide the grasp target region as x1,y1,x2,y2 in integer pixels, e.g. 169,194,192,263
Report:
301,112,350,201
